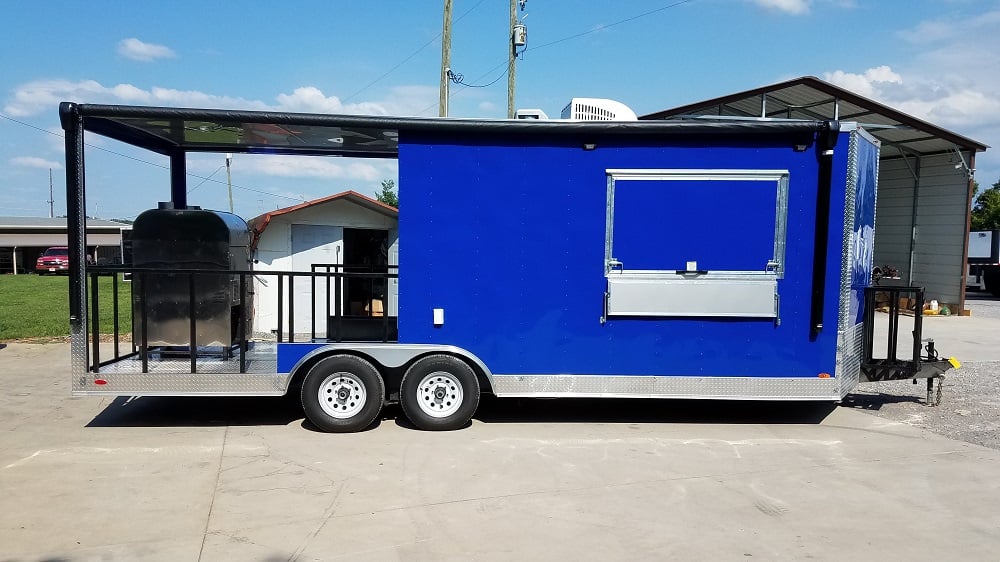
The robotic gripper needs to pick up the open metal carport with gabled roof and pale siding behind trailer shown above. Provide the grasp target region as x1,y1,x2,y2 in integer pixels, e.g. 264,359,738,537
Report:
640,76,989,308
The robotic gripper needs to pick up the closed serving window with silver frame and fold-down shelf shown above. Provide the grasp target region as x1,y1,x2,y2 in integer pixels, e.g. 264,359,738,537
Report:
605,169,789,318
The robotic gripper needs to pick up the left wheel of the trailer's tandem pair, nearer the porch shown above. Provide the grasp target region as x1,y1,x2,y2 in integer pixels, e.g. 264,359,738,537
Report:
301,355,385,433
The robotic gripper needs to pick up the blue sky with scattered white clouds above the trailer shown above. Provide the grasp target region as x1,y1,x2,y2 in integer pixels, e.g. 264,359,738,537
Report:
0,0,1000,219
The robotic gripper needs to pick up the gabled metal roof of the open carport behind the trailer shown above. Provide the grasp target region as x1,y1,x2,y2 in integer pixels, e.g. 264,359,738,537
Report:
640,76,989,157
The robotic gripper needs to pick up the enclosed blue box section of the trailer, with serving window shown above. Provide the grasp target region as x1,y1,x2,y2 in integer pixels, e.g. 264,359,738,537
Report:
268,128,878,400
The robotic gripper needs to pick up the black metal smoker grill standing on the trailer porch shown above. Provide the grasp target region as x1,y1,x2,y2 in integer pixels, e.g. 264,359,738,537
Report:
132,203,252,350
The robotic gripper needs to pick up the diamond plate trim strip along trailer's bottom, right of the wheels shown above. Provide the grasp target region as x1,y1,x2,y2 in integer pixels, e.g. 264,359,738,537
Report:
493,375,841,400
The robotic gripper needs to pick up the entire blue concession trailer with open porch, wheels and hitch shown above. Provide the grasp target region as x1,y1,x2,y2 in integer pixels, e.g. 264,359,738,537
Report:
60,103,952,431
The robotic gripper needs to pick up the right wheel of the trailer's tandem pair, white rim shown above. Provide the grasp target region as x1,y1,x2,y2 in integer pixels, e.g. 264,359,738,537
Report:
399,355,479,431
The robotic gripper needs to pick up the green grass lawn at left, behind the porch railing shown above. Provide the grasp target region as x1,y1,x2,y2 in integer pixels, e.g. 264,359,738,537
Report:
0,275,132,341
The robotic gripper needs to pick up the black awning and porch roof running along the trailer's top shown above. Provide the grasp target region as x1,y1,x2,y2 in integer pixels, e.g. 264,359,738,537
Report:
59,102,836,158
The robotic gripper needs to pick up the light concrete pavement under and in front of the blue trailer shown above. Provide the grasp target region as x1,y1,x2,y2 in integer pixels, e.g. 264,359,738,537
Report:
0,342,1000,561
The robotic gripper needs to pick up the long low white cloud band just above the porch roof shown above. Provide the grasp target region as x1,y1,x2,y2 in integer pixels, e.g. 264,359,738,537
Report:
4,80,437,117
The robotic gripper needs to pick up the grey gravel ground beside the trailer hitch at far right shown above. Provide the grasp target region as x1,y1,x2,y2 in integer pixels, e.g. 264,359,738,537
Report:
843,292,1000,449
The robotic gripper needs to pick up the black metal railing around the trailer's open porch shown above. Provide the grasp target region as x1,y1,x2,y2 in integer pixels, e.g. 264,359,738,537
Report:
87,264,398,373
